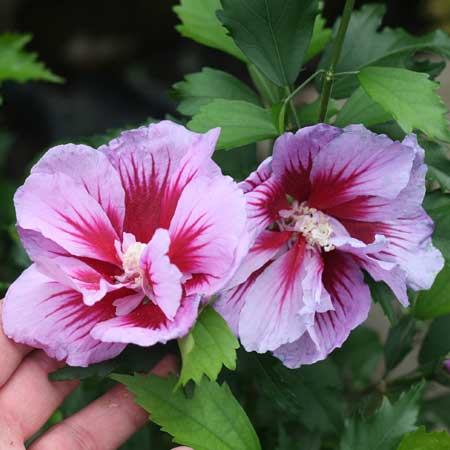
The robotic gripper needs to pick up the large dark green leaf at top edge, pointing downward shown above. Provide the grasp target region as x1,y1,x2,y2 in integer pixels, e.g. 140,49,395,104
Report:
218,0,318,86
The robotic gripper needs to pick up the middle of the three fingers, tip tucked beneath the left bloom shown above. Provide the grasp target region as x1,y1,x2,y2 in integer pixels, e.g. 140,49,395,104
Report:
0,351,78,440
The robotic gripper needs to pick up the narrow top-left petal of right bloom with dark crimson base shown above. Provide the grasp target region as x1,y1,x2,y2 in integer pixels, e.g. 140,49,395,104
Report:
272,124,342,202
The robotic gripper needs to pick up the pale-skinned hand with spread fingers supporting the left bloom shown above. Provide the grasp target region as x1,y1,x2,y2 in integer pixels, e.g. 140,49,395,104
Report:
0,301,192,450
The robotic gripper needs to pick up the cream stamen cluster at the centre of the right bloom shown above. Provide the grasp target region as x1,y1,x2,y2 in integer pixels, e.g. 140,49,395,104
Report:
279,201,335,252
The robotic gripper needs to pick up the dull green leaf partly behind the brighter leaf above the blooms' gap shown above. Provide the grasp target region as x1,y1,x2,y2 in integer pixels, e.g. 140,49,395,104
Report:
173,67,260,116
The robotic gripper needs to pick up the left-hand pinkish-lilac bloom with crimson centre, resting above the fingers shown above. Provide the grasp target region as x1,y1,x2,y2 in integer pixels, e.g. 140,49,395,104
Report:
3,121,248,366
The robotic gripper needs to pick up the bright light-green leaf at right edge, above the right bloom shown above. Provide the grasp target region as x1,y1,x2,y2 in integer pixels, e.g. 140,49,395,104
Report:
358,67,450,140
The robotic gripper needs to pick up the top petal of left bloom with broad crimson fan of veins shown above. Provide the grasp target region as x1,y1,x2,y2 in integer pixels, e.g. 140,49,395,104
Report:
99,121,220,243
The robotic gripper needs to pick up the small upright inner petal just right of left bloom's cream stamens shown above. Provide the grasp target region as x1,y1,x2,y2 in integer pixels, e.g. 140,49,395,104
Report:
140,228,182,320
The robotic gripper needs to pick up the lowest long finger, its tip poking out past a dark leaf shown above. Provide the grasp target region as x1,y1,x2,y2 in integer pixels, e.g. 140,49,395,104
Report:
30,356,177,450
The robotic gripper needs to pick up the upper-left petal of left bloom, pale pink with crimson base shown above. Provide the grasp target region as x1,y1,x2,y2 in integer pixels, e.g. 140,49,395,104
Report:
14,173,120,264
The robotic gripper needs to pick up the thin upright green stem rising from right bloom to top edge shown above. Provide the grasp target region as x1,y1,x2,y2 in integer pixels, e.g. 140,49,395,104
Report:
319,0,355,122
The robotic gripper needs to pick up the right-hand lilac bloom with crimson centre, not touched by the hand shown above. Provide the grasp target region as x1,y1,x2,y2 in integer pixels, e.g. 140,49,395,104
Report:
215,124,443,368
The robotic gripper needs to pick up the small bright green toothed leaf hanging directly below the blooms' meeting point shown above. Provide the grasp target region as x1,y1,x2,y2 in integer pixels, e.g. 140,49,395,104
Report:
179,306,239,386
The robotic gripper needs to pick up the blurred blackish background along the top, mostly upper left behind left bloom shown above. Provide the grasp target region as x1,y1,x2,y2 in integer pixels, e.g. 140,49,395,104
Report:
0,0,450,283
